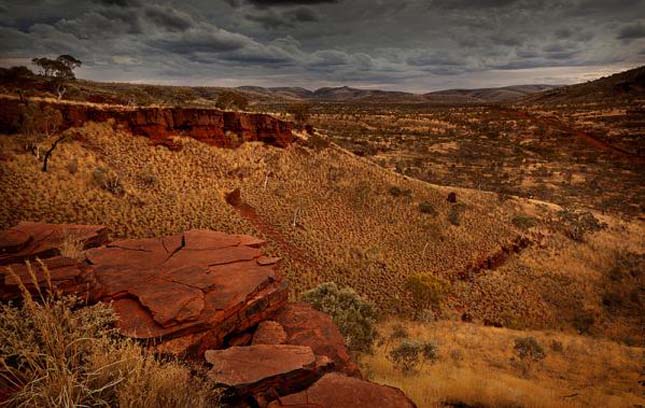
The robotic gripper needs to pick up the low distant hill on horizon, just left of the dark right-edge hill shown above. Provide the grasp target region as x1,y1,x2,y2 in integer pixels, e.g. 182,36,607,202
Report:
423,85,560,103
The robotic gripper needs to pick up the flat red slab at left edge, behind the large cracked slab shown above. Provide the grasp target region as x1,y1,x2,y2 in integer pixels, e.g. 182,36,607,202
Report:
0,222,108,265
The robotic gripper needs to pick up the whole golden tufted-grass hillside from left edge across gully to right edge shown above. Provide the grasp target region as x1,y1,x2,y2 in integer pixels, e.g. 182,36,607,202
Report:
0,118,645,339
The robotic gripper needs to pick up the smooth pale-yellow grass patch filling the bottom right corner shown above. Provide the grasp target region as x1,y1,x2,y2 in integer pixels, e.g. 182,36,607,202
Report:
361,322,645,408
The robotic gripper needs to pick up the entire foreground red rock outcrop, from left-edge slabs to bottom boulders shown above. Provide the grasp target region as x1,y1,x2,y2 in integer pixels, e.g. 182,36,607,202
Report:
0,222,415,408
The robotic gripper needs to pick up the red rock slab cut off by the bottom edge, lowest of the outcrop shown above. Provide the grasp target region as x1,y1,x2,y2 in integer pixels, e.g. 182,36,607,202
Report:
269,373,416,408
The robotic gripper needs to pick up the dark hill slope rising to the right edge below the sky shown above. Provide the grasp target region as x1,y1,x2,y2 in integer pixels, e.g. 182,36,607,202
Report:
522,66,645,104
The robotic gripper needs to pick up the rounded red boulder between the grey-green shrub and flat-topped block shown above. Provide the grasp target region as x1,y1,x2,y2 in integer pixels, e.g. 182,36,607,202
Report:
271,303,361,377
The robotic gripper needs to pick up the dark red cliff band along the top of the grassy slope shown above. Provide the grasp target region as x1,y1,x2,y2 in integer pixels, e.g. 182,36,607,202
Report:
0,99,293,147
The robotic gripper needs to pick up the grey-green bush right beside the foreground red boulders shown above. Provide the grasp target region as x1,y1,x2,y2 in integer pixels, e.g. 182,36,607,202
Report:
302,282,378,352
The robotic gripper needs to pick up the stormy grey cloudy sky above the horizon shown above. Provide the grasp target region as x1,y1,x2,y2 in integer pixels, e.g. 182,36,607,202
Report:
0,0,645,92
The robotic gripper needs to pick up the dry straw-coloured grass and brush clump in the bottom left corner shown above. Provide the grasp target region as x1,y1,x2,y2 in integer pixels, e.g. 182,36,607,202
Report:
0,264,215,408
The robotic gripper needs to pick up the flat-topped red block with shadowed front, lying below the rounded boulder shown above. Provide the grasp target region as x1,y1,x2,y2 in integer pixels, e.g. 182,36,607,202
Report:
205,344,330,399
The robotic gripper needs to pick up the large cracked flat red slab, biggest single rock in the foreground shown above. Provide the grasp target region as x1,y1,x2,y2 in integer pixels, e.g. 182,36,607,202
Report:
86,230,287,354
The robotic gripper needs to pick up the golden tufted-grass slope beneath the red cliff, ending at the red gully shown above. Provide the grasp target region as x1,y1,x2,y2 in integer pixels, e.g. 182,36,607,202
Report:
0,119,514,312
